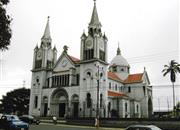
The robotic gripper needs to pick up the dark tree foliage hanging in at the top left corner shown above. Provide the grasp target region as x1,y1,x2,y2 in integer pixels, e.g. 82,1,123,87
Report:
0,0,12,50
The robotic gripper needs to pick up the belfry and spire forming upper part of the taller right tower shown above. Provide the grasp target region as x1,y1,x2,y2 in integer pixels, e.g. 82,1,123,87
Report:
80,0,108,64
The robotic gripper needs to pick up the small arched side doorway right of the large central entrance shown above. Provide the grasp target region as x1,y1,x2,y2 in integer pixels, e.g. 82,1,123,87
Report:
71,94,79,118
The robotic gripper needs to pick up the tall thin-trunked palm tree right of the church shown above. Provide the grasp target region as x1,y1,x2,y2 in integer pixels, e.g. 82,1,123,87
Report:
162,60,180,115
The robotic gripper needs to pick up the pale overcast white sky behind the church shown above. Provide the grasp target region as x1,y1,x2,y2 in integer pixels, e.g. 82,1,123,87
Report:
0,0,180,109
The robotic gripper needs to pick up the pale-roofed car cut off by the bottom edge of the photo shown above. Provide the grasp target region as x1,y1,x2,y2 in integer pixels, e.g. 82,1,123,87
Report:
125,125,161,130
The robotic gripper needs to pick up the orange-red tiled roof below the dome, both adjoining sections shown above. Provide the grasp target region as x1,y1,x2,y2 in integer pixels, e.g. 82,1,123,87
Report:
108,72,143,84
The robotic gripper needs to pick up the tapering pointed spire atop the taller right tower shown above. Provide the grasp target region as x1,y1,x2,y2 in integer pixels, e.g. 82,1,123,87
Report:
89,0,101,28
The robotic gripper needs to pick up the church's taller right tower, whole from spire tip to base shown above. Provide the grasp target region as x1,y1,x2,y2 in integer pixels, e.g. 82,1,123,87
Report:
80,0,108,117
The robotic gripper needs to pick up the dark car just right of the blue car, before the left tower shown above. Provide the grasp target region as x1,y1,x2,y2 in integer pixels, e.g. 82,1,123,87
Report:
19,115,40,125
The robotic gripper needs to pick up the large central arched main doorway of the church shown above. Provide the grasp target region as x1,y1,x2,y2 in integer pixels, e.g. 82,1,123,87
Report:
51,89,68,117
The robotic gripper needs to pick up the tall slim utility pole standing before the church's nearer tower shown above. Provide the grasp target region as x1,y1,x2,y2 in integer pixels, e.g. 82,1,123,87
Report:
95,64,103,128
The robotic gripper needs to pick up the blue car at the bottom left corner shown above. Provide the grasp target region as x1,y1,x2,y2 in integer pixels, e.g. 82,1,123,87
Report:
0,115,29,130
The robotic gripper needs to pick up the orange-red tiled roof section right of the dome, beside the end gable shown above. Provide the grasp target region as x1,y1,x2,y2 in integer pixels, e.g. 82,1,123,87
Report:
124,73,143,83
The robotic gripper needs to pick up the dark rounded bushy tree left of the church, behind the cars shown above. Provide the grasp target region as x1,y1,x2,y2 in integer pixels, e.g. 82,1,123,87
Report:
0,88,30,114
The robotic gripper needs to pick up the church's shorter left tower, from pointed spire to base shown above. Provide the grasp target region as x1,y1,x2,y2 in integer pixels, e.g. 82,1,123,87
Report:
29,17,57,116
